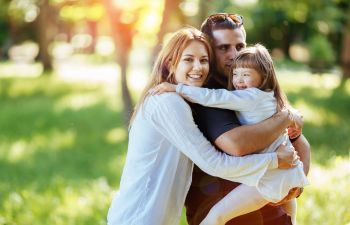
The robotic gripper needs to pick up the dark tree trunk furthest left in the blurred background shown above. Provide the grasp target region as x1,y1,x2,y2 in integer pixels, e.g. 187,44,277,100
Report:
37,0,52,74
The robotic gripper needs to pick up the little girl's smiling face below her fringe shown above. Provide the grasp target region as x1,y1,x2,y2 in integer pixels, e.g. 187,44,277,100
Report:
232,68,262,90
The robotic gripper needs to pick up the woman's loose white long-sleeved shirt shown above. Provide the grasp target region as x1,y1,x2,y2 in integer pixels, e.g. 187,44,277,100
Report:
108,93,278,225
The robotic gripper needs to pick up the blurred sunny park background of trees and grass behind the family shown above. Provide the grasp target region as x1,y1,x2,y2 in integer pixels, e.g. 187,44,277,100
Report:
0,0,350,225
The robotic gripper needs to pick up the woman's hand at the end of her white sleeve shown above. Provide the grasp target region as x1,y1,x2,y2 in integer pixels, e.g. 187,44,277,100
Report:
276,144,299,169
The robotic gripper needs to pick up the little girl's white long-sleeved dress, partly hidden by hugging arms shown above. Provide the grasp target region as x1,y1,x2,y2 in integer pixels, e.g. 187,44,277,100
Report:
176,84,308,202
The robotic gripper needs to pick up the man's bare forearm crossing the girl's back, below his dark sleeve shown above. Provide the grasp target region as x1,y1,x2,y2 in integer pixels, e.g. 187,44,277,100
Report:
214,111,292,157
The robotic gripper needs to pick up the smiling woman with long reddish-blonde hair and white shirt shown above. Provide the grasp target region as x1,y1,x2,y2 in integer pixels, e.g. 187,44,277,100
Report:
108,28,296,225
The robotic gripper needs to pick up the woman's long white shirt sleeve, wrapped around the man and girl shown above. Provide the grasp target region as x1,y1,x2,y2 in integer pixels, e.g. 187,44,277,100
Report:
146,93,278,186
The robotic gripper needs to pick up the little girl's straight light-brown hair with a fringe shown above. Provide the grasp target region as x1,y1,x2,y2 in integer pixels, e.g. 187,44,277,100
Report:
228,44,288,111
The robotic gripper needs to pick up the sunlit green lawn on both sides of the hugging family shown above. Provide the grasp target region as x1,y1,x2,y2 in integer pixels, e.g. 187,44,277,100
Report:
0,62,350,225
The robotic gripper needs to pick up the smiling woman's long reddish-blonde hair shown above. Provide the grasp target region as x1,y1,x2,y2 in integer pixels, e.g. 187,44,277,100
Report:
129,27,213,128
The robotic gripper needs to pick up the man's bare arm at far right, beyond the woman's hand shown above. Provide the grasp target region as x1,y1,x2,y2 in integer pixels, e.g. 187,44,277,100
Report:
293,135,311,175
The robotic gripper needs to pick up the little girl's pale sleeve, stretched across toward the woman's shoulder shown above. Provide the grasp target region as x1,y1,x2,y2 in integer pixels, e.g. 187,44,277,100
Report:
176,84,260,111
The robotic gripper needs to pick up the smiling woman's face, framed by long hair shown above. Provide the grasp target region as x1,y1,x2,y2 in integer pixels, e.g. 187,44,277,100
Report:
175,40,209,87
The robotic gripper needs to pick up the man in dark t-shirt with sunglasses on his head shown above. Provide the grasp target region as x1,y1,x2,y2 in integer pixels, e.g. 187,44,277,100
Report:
185,13,310,225
